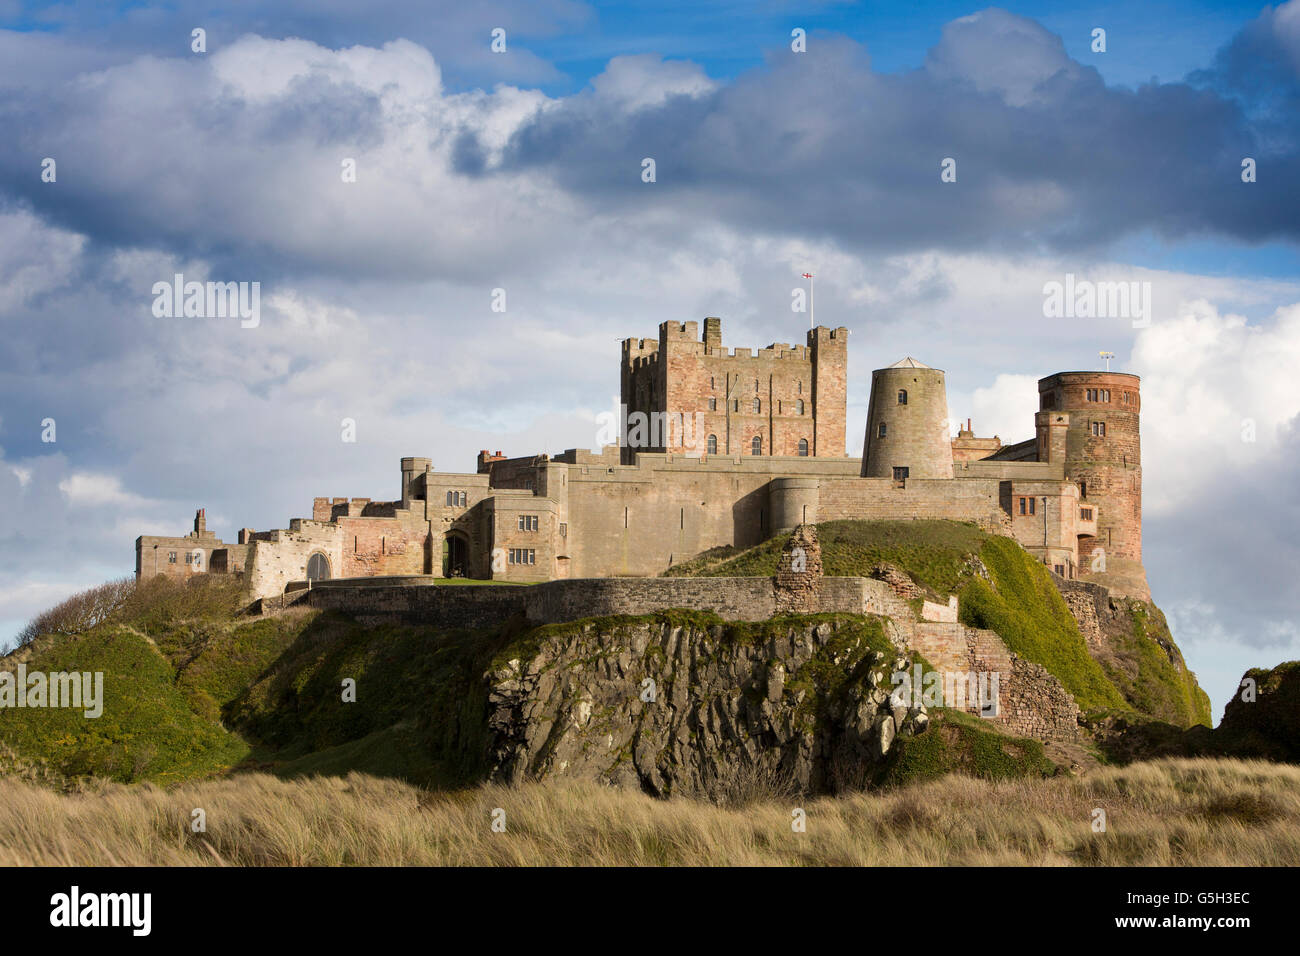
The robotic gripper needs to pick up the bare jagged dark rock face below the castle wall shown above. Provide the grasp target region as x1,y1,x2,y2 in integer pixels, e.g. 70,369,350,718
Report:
488,617,928,801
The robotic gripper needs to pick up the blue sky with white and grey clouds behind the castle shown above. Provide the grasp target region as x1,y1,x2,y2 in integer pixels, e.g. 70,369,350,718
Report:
0,0,1300,714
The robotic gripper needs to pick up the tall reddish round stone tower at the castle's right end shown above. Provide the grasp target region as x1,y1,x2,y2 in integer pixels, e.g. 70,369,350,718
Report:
1039,372,1147,593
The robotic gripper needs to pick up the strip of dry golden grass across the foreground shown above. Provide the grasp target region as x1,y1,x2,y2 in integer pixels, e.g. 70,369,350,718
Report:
0,760,1300,866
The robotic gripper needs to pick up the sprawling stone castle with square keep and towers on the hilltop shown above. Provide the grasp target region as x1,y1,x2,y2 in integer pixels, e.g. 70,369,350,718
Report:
135,317,1149,598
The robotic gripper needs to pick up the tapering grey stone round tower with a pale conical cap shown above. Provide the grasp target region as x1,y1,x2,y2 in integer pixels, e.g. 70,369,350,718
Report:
862,358,953,480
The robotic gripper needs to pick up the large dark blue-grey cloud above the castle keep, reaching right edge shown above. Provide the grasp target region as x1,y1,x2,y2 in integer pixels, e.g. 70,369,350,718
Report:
489,9,1300,250
